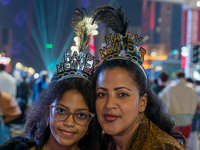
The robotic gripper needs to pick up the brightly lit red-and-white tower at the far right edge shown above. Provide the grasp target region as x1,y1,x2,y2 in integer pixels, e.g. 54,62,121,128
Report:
182,0,200,80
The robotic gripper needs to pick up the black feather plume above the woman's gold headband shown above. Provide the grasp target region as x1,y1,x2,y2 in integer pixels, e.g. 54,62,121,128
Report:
93,5,130,35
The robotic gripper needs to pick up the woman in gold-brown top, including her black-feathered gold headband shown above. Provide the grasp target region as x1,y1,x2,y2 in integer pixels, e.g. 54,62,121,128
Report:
94,6,184,150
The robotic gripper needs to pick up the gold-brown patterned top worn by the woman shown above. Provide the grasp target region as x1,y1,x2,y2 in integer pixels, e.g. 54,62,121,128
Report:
99,120,184,150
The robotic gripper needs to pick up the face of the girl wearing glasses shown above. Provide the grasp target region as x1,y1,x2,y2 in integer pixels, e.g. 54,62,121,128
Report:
49,90,89,148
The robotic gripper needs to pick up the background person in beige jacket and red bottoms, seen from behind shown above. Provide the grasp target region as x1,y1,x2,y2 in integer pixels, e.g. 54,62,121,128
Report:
159,70,198,146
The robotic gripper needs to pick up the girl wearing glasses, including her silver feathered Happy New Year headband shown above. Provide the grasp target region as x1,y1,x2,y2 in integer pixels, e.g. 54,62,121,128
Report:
0,7,101,150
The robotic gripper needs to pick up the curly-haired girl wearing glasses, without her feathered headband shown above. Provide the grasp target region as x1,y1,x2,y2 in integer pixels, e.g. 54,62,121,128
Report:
1,77,101,150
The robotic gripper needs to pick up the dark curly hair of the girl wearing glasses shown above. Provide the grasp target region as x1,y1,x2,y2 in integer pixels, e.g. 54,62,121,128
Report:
24,76,101,150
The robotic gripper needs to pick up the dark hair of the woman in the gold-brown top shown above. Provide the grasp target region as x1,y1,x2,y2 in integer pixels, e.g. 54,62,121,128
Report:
93,59,185,147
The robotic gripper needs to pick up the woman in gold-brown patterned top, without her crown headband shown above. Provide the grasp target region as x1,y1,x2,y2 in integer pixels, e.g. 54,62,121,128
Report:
94,60,183,150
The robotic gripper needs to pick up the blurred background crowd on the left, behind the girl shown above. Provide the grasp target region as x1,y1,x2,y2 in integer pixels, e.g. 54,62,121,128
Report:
0,64,50,143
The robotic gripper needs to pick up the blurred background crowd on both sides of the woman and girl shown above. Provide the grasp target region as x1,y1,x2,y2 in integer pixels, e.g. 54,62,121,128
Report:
0,61,200,150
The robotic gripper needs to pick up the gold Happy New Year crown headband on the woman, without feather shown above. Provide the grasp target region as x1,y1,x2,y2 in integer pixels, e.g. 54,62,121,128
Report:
99,33,147,80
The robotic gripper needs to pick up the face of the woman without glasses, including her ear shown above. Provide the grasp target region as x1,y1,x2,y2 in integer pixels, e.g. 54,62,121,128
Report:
96,67,147,136
